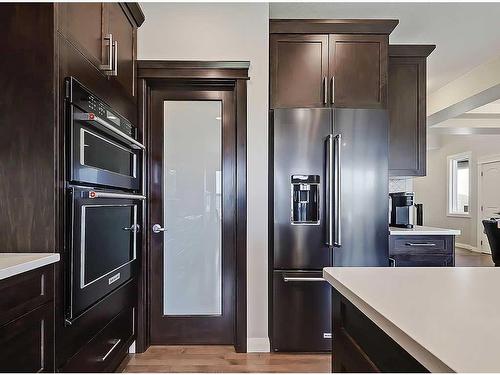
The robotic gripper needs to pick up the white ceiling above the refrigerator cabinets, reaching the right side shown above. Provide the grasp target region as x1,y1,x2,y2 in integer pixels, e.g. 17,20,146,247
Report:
269,3,500,92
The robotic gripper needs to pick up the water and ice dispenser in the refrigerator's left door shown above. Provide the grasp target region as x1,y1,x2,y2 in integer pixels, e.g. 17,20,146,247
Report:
291,175,320,225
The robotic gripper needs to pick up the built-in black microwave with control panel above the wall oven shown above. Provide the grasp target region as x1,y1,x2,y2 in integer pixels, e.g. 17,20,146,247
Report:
66,77,144,190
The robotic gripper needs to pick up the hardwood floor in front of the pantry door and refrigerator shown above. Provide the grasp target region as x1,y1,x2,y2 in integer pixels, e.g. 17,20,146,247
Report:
120,346,331,372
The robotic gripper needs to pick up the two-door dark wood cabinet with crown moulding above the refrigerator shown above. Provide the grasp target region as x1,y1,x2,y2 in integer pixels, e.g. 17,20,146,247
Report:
269,20,398,108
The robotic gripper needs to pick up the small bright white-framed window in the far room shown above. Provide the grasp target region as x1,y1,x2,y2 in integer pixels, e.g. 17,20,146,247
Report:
448,152,471,217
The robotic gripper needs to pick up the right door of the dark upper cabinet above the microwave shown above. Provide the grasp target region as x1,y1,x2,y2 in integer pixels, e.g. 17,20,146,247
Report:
104,3,136,96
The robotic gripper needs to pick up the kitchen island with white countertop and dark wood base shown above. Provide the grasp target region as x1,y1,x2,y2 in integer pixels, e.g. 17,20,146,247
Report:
323,267,500,372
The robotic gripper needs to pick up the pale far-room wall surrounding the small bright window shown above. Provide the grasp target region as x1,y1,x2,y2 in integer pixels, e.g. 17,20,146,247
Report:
413,135,500,247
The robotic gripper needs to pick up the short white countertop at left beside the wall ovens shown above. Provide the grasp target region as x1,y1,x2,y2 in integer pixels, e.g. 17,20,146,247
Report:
0,253,60,280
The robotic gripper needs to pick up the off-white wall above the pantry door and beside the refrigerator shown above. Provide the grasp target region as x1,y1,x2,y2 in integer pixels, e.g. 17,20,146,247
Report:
137,3,269,351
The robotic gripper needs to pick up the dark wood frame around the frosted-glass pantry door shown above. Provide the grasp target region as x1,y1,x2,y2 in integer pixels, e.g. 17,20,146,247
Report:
136,60,250,352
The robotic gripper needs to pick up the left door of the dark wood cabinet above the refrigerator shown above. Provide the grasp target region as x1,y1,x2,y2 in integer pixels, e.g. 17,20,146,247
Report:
270,34,328,108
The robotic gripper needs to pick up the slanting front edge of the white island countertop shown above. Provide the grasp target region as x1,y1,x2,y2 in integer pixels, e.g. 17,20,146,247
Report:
323,269,455,373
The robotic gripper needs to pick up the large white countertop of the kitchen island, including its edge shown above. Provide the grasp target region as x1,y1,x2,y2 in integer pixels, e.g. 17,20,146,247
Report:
323,267,500,372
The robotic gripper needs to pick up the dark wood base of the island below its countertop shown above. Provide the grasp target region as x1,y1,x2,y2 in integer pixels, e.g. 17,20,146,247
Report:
332,289,429,373
